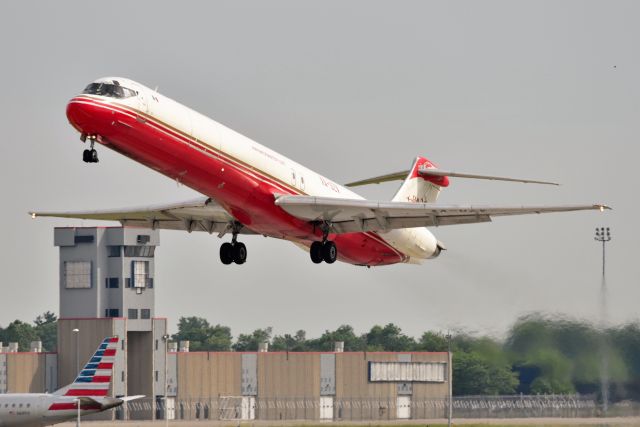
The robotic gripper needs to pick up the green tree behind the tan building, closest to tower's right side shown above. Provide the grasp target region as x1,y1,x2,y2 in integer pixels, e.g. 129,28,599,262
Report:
172,316,232,351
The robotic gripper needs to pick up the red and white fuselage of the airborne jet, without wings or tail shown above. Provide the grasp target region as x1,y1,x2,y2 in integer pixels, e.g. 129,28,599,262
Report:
67,75,439,265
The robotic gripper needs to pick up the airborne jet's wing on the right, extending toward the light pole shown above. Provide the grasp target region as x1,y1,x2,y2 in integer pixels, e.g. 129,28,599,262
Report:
275,196,610,234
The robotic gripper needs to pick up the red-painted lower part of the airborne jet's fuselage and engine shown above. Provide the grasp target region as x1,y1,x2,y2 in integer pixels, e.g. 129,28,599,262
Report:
67,97,406,265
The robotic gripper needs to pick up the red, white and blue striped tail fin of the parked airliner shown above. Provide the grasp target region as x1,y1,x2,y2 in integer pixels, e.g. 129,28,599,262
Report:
54,337,118,397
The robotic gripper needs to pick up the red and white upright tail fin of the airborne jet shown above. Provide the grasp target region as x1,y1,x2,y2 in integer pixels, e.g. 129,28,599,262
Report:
392,157,449,203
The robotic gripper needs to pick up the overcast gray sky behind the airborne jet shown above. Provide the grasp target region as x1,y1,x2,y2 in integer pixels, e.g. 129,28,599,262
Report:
0,0,640,336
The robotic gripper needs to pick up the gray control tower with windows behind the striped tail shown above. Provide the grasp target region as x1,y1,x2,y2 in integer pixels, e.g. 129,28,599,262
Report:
54,227,167,419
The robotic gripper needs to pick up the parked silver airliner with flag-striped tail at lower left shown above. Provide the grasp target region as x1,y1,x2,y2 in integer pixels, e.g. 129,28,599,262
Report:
0,337,144,427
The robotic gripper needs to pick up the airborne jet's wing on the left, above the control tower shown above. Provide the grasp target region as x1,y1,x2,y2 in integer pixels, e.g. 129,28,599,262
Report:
29,197,253,234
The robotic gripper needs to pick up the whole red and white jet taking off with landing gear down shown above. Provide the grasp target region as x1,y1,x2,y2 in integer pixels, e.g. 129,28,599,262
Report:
31,77,607,266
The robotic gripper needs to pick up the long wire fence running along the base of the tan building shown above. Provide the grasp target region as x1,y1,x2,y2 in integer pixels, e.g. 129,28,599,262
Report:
116,395,616,421
